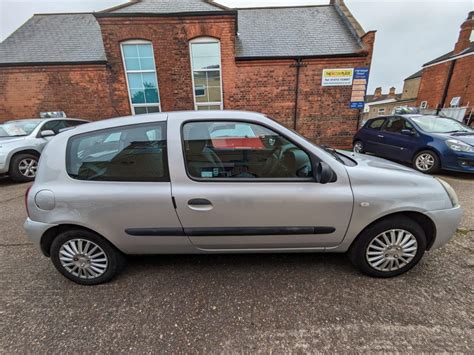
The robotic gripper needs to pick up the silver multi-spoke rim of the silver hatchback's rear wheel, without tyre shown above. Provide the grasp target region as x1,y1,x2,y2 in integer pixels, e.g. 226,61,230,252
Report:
59,239,108,279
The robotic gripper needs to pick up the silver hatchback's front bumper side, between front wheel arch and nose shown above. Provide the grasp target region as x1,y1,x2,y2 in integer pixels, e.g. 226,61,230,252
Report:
426,206,462,249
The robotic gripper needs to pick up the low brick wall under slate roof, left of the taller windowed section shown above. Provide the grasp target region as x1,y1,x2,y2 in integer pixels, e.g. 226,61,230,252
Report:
0,65,117,122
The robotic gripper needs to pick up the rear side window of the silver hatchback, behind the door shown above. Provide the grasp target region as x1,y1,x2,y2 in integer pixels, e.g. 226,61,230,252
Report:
66,123,169,181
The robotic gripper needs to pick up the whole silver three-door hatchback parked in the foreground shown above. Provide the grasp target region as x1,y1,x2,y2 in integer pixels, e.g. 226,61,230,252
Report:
25,111,461,285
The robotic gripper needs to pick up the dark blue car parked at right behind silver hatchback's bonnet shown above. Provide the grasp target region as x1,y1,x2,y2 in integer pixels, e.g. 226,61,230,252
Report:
353,115,474,173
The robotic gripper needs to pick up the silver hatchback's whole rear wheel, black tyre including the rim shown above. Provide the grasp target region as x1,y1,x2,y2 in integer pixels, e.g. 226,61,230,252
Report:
50,229,125,285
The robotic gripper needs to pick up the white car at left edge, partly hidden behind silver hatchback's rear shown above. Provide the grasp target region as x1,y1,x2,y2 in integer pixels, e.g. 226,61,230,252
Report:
0,118,88,182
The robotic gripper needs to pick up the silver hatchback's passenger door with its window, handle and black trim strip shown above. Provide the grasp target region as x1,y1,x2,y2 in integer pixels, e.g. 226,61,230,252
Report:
168,120,353,251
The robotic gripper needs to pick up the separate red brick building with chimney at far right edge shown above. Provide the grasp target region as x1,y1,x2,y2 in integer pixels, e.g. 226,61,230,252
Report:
417,11,474,117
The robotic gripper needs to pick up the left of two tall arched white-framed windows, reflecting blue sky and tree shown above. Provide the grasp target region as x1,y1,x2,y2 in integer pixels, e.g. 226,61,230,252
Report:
121,40,161,115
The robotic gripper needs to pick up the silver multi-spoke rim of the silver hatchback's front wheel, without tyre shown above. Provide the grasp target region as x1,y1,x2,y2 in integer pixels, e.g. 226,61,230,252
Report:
366,229,418,272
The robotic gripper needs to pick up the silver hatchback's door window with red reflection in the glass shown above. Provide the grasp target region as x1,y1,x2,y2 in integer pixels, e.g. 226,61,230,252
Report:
182,121,312,179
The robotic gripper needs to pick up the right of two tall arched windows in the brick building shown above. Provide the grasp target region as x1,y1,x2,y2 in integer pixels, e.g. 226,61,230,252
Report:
189,37,224,110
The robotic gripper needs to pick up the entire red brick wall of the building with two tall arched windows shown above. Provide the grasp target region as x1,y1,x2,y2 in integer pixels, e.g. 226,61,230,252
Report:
0,15,375,147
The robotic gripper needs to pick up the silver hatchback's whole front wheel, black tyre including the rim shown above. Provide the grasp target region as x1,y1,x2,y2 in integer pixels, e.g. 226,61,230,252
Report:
348,216,426,277
